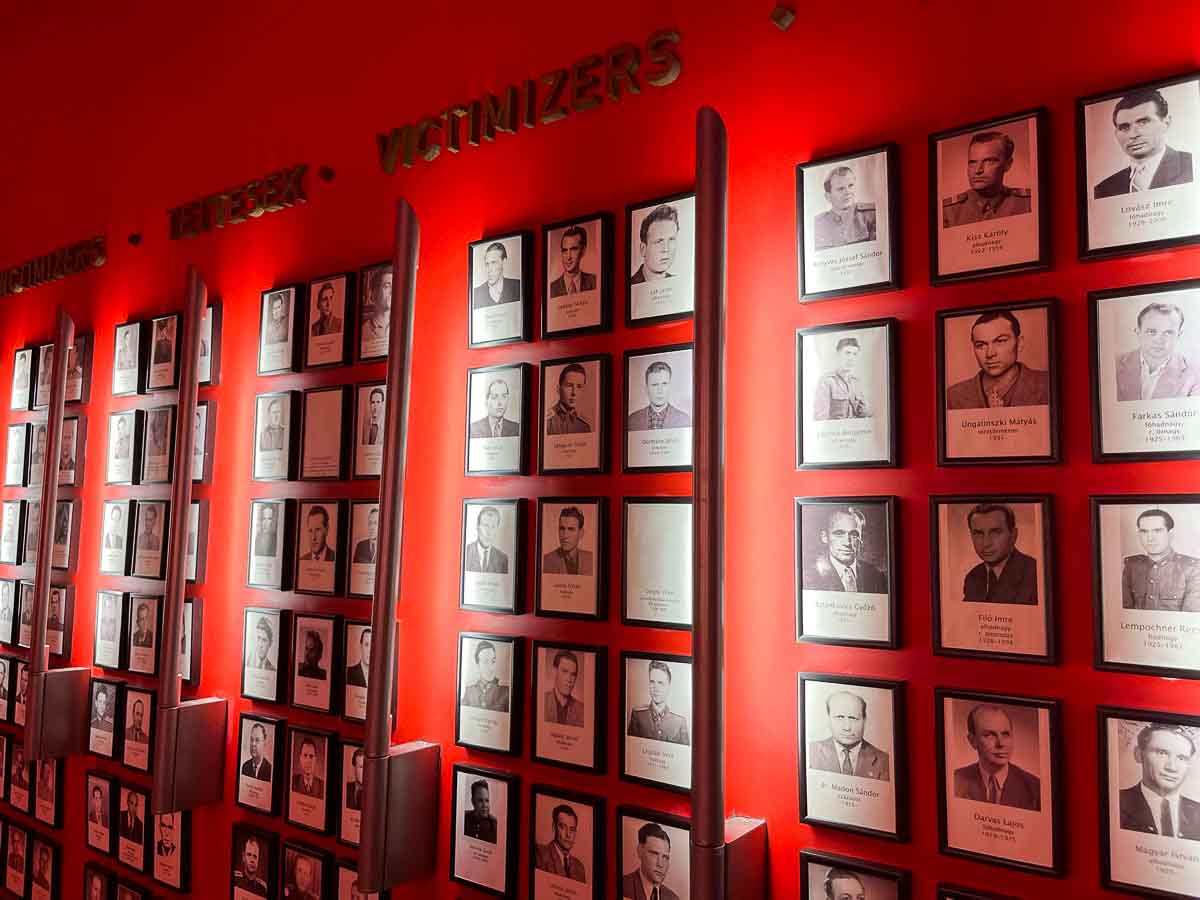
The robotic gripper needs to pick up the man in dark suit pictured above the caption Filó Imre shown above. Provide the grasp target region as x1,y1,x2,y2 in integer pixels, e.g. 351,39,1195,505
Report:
962,503,1038,606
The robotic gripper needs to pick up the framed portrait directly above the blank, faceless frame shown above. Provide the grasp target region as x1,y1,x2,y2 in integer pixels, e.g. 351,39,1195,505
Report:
622,343,692,472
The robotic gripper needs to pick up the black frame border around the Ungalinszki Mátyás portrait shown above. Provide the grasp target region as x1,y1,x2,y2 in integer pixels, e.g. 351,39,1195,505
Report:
934,296,1062,466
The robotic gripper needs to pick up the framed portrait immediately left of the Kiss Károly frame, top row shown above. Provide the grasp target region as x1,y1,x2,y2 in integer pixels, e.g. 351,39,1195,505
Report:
796,144,901,301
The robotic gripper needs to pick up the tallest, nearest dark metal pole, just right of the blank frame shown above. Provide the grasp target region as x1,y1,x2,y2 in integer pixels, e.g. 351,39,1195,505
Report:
691,107,727,900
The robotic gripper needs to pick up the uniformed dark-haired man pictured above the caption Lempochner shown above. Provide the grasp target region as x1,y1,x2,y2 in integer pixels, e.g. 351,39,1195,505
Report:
1121,509,1200,612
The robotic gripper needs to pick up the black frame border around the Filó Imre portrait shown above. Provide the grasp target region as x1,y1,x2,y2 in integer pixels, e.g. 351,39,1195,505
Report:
929,493,1058,666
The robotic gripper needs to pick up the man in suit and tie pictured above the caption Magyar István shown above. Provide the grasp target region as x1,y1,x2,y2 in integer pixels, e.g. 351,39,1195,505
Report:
1120,722,1200,841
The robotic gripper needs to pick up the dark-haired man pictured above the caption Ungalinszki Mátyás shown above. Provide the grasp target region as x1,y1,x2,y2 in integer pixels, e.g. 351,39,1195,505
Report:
946,310,1050,409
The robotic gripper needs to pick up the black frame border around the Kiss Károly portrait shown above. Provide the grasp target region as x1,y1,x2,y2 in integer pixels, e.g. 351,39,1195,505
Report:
929,107,1052,287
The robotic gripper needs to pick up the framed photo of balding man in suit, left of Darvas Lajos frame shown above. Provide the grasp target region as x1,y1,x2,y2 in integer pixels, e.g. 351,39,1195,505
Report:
797,672,908,841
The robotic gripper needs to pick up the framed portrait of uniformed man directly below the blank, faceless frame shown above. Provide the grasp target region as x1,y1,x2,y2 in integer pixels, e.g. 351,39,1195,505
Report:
620,650,691,793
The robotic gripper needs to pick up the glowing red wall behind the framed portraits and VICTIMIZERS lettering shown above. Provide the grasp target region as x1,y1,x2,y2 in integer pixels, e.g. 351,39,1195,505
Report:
0,0,1200,898
